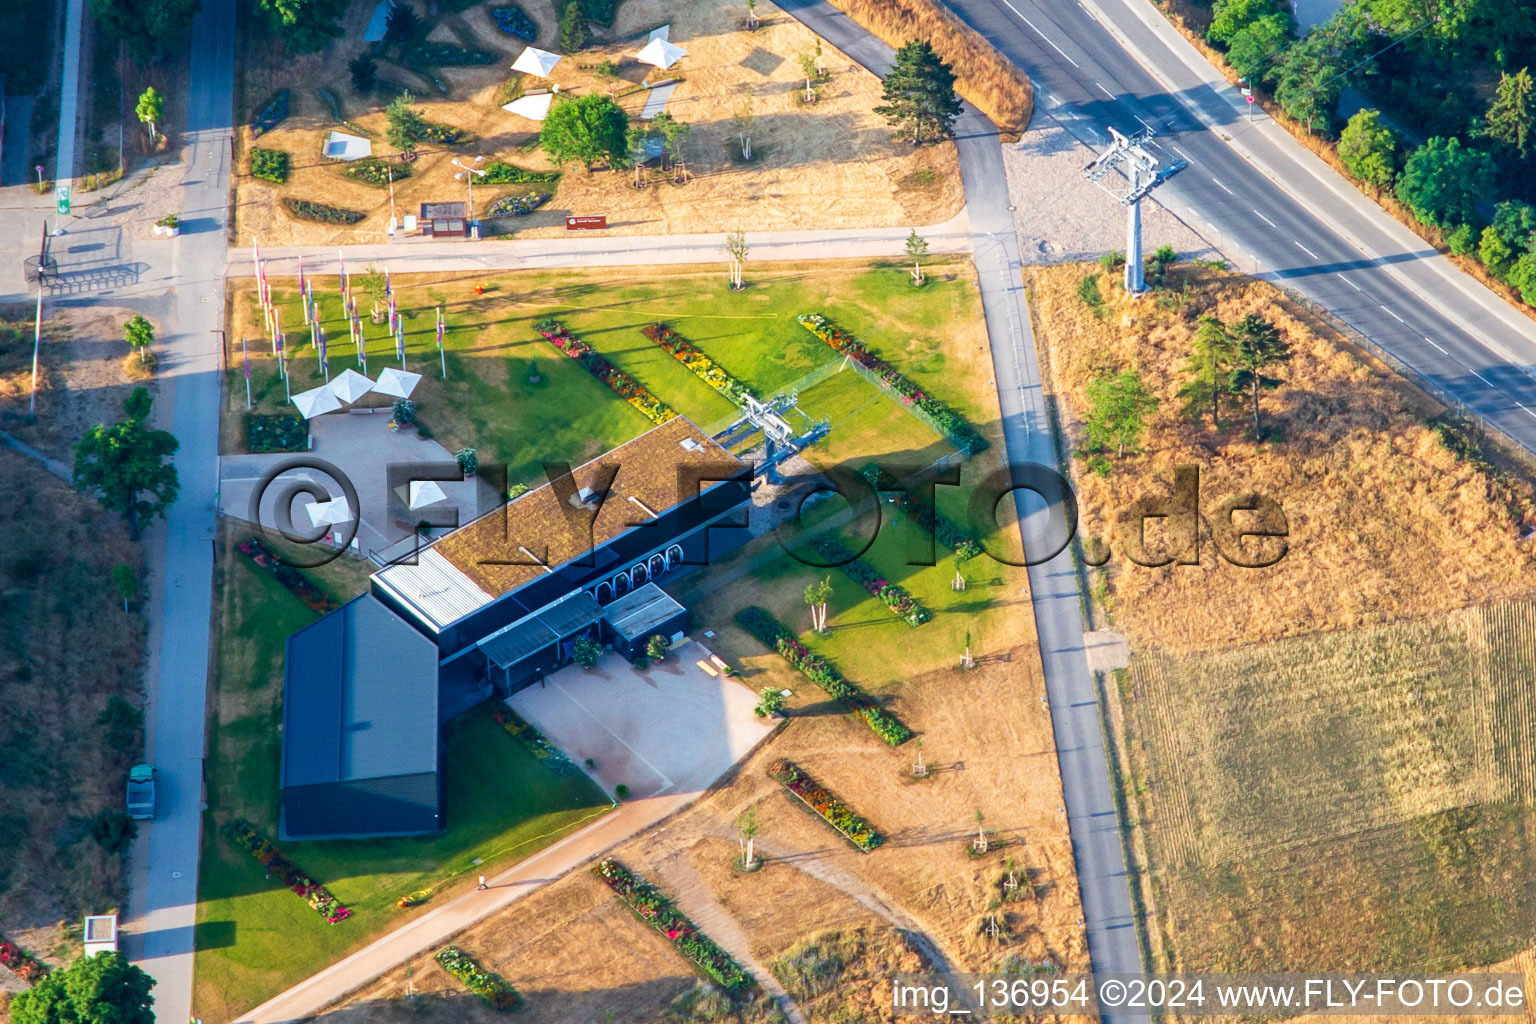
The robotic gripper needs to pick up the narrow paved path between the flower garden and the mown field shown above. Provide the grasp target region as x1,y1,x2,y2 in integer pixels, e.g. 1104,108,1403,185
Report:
777,0,1141,1021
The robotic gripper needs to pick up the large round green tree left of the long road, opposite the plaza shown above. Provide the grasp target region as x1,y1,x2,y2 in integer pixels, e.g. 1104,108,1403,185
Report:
74,387,181,540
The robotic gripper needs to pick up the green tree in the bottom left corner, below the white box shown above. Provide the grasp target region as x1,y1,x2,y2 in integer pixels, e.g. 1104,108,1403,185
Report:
11,952,155,1024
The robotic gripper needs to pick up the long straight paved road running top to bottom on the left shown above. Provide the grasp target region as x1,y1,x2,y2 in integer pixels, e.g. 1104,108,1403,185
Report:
124,0,235,1022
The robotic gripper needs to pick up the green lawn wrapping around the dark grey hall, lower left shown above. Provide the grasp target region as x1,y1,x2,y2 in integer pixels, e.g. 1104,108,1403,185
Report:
195,540,610,1019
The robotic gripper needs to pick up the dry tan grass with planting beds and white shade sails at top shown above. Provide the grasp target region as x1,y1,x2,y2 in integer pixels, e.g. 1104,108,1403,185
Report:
237,0,965,244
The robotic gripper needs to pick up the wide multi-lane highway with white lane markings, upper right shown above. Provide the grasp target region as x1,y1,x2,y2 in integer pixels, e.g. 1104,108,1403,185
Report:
946,0,1536,448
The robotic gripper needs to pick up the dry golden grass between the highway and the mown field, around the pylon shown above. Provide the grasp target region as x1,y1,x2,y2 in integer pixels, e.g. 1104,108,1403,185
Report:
1029,266,1533,651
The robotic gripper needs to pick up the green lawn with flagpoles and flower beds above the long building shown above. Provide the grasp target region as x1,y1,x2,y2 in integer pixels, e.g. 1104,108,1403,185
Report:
224,254,988,485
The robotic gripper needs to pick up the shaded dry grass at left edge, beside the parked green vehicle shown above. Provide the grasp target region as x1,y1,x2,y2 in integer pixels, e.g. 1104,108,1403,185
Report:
0,450,144,963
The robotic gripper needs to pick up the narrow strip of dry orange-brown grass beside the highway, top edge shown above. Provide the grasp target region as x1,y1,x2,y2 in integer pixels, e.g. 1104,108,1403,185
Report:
831,0,1035,141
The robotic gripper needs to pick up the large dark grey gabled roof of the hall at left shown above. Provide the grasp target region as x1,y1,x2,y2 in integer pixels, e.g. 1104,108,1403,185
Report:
283,594,438,788
